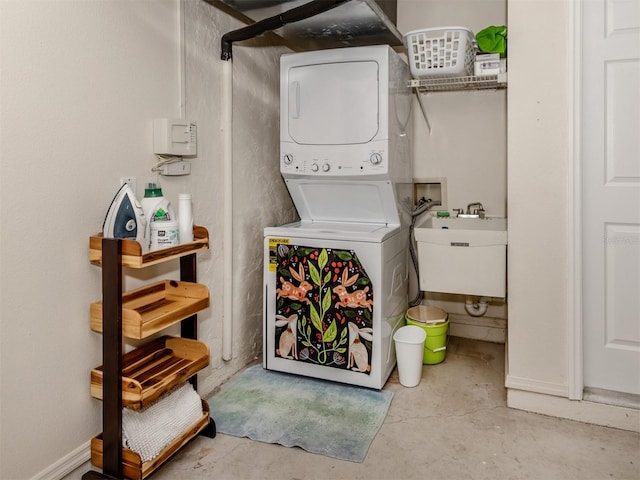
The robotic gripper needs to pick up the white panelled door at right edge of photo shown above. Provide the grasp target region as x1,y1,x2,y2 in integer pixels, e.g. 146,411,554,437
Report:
581,0,640,395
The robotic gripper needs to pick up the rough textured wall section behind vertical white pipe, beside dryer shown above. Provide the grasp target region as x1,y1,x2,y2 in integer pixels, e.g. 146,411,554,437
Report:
185,0,295,393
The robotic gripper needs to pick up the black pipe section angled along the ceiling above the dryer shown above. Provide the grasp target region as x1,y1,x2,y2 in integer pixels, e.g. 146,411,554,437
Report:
220,0,351,61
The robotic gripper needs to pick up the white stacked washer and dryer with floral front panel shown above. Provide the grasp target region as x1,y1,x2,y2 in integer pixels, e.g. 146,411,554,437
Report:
263,45,413,389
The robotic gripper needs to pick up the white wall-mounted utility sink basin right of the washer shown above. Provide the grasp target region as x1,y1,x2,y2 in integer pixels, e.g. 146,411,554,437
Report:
414,215,507,298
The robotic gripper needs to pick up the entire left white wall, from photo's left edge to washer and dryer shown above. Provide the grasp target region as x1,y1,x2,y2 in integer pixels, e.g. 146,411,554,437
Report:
0,0,294,479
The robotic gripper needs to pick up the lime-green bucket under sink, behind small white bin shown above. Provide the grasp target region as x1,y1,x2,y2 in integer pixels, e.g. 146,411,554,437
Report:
405,305,449,365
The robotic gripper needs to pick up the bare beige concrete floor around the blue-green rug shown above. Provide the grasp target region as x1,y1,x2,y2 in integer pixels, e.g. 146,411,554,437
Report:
152,337,640,480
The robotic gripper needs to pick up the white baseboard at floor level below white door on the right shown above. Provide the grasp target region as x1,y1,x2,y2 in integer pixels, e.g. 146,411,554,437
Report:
507,387,640,433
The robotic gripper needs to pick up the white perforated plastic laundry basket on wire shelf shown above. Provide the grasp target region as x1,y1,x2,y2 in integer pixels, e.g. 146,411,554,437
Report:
404,27,476,78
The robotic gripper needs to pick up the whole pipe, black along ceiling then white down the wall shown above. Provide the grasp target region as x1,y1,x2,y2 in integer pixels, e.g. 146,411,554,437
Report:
220,0,350,361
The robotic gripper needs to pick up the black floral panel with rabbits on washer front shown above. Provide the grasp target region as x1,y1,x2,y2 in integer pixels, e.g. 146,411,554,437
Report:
275,244,374,374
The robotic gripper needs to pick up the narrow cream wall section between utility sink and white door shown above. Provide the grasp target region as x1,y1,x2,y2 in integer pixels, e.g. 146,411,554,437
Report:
507,0,570,396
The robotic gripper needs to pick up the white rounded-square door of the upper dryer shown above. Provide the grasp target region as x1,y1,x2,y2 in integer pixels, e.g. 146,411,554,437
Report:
282,61,379,145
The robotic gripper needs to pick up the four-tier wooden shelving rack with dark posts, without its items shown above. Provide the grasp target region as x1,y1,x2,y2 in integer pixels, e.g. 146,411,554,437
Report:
82,226,216,480
